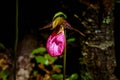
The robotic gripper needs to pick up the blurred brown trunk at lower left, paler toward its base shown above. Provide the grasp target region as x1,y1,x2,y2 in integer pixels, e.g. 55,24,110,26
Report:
15,35,37,80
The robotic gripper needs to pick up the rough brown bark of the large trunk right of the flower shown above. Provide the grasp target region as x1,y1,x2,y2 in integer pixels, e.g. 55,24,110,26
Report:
80,0,117,80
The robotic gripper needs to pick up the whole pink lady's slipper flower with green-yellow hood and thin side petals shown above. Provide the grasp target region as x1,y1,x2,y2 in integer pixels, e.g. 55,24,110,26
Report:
40,12,85,57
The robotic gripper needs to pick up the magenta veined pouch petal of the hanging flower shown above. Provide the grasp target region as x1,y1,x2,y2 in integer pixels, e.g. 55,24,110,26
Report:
46,31,66,57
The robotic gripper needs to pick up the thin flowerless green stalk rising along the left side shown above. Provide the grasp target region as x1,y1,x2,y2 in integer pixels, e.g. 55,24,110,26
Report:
13,0,18,80
